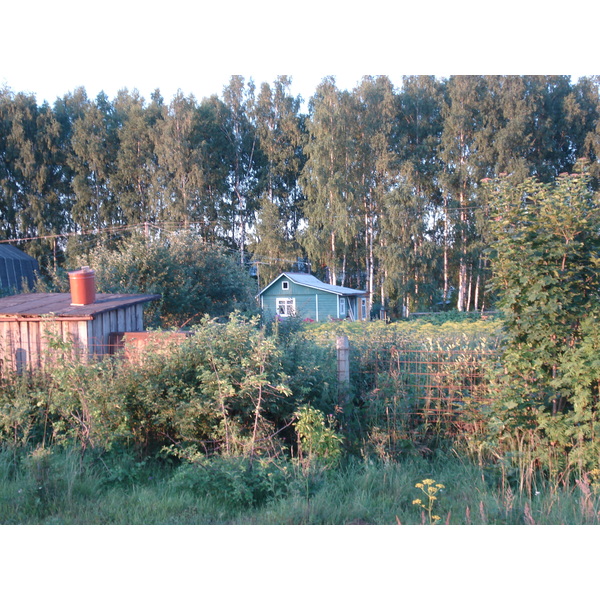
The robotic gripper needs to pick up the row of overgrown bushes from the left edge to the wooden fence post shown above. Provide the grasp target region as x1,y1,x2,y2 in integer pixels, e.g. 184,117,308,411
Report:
0,313,336,458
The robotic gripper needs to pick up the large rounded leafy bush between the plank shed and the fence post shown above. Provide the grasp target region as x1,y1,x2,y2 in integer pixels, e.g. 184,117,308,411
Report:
94,314,293,454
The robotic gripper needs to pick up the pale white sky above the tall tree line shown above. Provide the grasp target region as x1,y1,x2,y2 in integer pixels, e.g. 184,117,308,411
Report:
0,0,600,104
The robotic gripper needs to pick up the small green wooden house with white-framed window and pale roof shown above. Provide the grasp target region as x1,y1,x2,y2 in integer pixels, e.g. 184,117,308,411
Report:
258,273,368,321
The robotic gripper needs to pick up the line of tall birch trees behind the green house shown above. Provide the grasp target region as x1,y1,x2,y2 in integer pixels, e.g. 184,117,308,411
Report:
0,76,600,314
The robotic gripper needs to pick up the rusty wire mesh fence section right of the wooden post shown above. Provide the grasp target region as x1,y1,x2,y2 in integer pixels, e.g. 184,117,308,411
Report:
353,344,499,445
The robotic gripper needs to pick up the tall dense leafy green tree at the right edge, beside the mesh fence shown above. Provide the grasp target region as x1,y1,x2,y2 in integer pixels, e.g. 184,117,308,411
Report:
490,174,600,473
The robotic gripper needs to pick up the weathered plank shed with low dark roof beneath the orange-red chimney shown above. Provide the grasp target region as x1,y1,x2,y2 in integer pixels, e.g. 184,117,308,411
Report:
0,293,160,372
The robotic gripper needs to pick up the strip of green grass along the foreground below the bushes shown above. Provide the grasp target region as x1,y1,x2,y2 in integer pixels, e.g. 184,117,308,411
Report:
0,451,600,526
